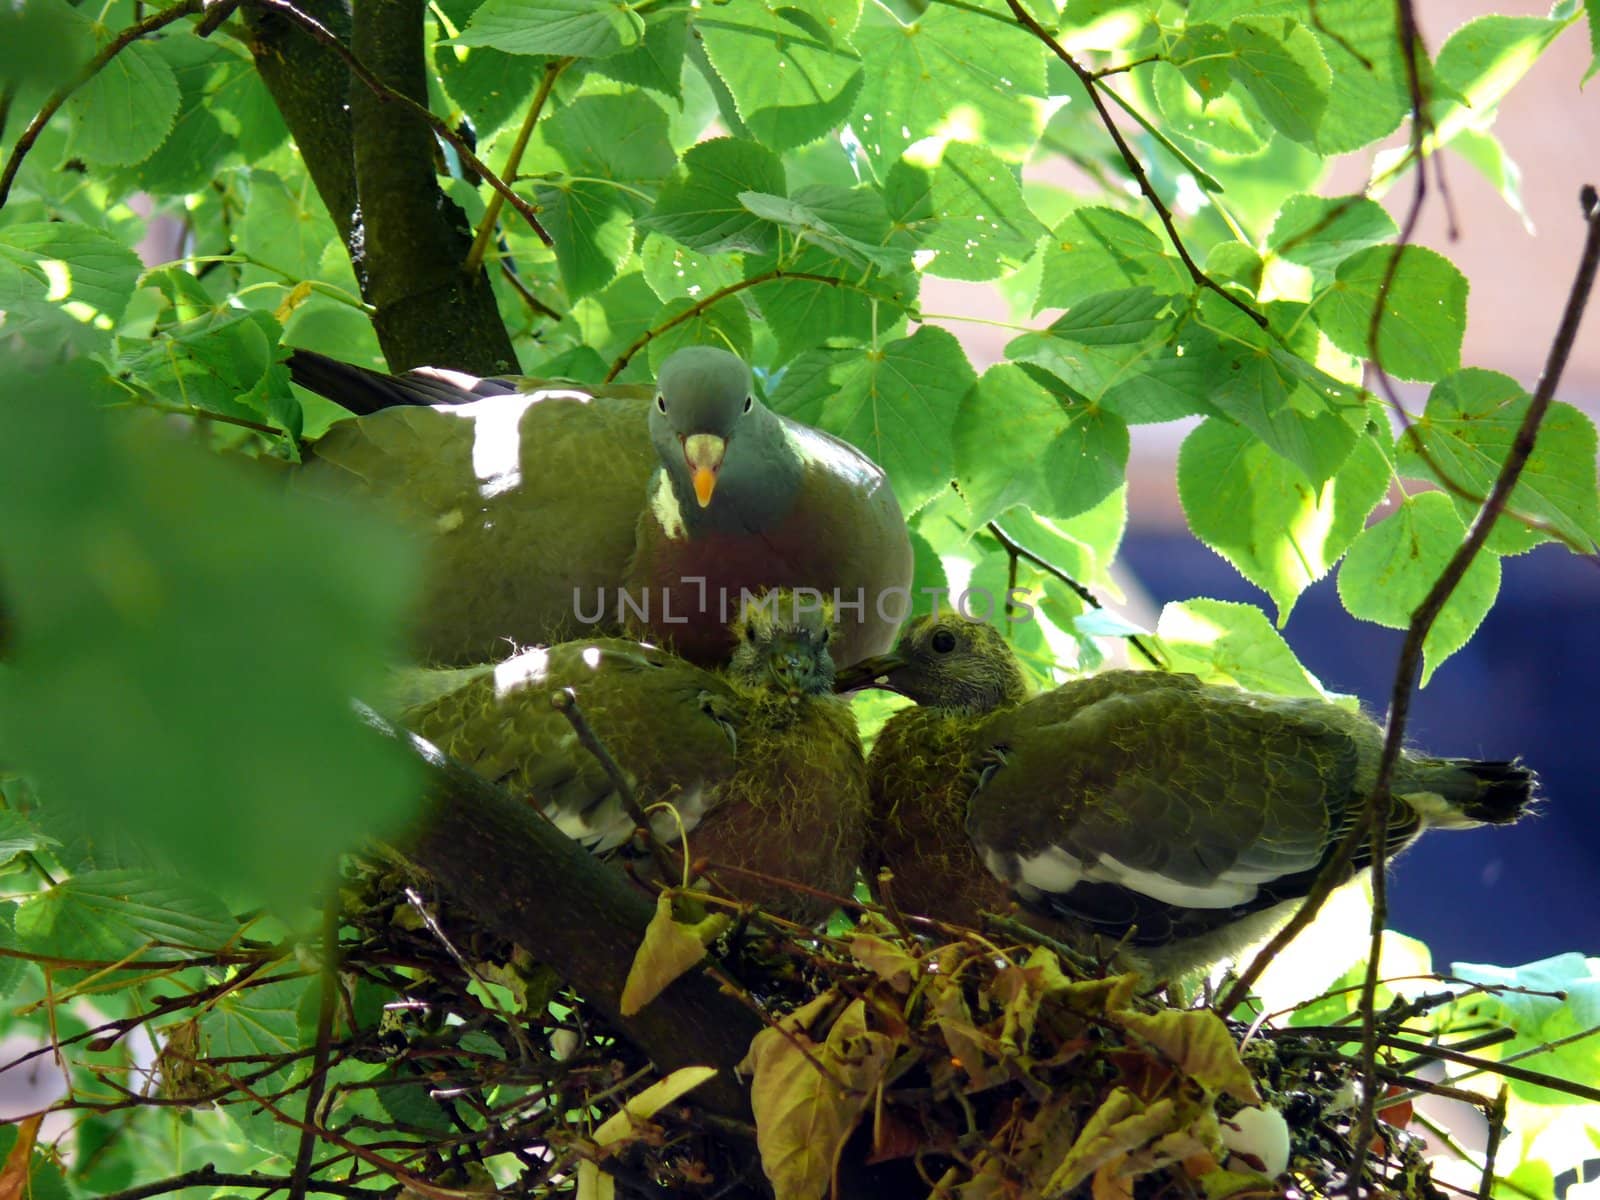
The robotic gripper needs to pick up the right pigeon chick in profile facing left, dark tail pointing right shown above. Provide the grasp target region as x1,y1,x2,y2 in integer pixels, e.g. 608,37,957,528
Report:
840,614,1536,978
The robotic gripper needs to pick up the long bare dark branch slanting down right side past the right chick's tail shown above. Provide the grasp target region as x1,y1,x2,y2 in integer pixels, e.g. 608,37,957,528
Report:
1219,186,1600,1013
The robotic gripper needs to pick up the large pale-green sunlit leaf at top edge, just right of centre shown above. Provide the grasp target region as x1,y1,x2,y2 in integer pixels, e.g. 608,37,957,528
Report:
850,0,1045,166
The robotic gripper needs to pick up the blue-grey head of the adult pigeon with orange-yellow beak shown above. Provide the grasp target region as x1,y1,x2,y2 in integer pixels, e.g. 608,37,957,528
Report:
650,346,782,510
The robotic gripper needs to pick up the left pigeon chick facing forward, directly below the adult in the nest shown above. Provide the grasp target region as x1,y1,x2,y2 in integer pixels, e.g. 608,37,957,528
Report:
402,592,867,922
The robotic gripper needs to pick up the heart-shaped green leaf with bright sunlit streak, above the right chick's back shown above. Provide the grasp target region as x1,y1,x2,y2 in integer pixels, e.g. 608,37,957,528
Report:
1178,419,1389,629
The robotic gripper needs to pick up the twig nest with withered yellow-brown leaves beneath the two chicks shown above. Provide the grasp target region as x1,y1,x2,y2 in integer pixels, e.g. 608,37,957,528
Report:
288,869,1472,1200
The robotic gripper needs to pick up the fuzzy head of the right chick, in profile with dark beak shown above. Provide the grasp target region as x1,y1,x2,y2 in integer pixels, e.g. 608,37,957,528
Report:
837,613,1027,712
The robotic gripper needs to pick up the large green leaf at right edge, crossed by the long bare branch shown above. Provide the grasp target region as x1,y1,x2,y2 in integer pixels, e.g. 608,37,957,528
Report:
1400,368,1600,554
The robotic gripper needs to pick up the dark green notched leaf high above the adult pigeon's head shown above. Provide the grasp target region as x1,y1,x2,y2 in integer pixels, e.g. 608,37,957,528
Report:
638,138,789,254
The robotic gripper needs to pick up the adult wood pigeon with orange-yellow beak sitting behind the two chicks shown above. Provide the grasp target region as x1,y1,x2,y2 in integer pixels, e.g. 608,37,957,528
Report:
290,346,912,666
